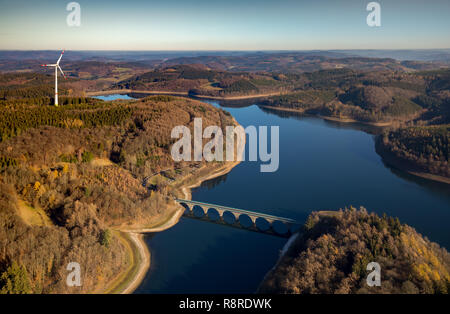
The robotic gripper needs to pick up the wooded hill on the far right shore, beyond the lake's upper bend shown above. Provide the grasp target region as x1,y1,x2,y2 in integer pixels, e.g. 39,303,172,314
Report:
262,69,450,124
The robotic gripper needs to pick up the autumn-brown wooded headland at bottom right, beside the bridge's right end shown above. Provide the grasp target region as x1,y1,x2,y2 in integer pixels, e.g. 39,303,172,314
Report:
259,208,450,294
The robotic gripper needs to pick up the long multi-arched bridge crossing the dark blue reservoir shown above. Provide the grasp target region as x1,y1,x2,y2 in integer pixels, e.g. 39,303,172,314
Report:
175,199,300,237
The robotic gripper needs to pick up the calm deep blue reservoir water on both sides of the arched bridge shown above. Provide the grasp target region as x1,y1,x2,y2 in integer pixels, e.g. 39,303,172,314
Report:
101,94,450,293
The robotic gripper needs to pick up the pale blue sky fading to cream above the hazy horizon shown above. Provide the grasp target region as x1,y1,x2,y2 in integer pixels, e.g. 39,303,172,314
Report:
0,0,450,50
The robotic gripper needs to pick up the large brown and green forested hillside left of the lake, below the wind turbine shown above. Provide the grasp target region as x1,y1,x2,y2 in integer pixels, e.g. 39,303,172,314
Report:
0,92,235,293
